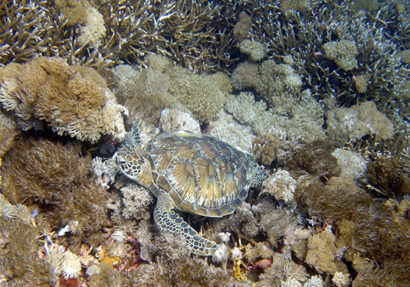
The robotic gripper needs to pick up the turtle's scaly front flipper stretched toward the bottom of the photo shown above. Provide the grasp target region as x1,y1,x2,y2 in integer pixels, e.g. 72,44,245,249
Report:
154,194,217,256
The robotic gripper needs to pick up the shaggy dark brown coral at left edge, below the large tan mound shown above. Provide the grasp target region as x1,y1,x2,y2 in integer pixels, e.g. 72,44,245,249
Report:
1,138,107,232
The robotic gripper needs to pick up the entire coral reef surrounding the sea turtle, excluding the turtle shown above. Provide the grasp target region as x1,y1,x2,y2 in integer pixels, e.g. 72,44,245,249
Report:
0,0,410,287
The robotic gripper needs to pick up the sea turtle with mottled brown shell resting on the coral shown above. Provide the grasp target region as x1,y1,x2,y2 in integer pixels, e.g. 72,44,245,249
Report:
113,125,266,256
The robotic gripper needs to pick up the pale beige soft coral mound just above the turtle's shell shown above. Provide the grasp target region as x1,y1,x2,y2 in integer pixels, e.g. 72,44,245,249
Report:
115,56,226,122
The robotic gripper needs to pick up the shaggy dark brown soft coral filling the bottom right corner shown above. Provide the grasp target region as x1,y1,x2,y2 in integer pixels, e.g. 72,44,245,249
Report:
295,177,410,286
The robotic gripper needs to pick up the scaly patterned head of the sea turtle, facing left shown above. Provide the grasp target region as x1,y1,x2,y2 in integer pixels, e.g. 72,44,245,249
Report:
115,150,152,187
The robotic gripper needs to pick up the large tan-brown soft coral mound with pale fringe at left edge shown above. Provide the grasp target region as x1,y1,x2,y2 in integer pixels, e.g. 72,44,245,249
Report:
0,57,126,141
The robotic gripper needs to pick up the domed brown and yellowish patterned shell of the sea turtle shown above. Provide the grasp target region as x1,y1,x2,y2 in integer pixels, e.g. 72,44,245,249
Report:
148,131,255,217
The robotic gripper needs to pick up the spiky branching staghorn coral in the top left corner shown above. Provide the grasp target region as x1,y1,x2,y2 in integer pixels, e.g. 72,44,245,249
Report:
0,0,69,66
